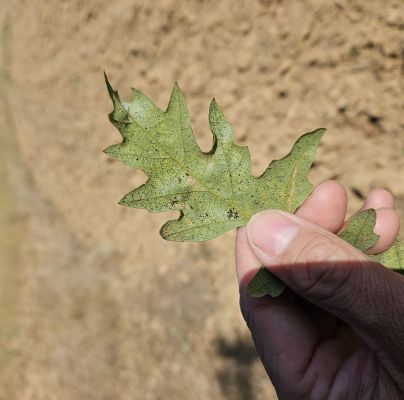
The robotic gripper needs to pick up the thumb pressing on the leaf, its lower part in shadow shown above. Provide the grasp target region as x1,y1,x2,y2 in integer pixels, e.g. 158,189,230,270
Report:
247,210,404,339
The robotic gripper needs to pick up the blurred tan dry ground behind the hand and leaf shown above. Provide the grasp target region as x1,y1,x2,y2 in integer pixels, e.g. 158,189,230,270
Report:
0,0,404,400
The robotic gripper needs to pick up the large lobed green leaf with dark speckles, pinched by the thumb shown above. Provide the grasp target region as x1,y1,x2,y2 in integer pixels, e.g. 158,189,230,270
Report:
105,79,325,241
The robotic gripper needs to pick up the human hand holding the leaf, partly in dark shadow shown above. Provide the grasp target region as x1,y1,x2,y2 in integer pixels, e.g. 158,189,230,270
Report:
236,181,404,400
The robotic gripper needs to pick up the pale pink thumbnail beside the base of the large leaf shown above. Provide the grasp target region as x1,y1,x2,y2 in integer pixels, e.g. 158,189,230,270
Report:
247,211,300,263
